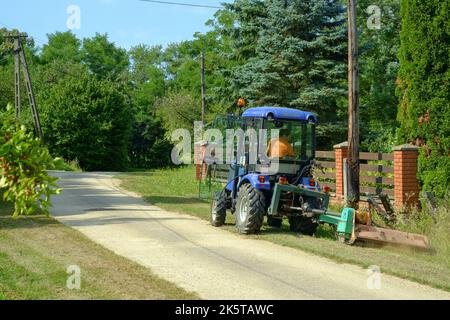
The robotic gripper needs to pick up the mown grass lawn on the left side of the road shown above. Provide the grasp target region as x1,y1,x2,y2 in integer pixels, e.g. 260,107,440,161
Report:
0,202,198,300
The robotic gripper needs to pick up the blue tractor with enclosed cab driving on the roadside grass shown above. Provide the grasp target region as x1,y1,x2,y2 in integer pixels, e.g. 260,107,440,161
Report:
211,107,329,235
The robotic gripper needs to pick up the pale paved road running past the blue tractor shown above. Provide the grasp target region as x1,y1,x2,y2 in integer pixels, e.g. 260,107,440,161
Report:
53,173,450,300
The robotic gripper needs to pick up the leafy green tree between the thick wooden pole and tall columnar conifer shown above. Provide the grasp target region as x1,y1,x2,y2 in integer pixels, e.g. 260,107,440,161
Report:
358,0,401,152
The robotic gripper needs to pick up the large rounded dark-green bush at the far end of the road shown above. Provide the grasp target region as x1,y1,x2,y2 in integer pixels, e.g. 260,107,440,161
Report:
41,73,133,171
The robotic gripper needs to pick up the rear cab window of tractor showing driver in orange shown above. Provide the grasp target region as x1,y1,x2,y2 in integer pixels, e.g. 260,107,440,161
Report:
264,120,315,162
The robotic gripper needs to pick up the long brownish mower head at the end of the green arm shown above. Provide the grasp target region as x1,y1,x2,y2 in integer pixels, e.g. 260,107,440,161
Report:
355,224,430,250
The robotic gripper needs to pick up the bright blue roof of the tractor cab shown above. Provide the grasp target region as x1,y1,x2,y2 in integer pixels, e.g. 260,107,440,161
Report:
242,107,317,123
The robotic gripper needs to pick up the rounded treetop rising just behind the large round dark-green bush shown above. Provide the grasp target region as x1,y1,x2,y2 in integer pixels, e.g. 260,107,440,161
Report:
81,33,130,80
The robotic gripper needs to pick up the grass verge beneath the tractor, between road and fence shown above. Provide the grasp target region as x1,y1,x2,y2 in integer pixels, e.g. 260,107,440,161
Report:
118,166,450,291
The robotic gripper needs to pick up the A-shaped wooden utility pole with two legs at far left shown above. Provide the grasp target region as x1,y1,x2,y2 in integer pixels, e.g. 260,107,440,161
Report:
5,33,43,141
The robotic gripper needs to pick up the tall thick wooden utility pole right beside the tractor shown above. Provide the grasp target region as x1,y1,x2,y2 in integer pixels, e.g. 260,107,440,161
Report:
347,0,360,209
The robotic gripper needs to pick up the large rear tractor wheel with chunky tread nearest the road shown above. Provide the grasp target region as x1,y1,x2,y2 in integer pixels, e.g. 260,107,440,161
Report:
235,184,265,234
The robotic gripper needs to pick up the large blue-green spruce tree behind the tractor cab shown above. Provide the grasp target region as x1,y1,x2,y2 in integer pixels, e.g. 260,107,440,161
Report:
235,0,346,121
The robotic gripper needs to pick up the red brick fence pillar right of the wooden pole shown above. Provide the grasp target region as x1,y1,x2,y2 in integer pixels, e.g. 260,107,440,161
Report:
393,144,419,208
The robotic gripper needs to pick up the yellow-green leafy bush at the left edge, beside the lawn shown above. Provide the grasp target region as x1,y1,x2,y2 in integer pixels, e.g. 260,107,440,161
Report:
0,108,59,217
